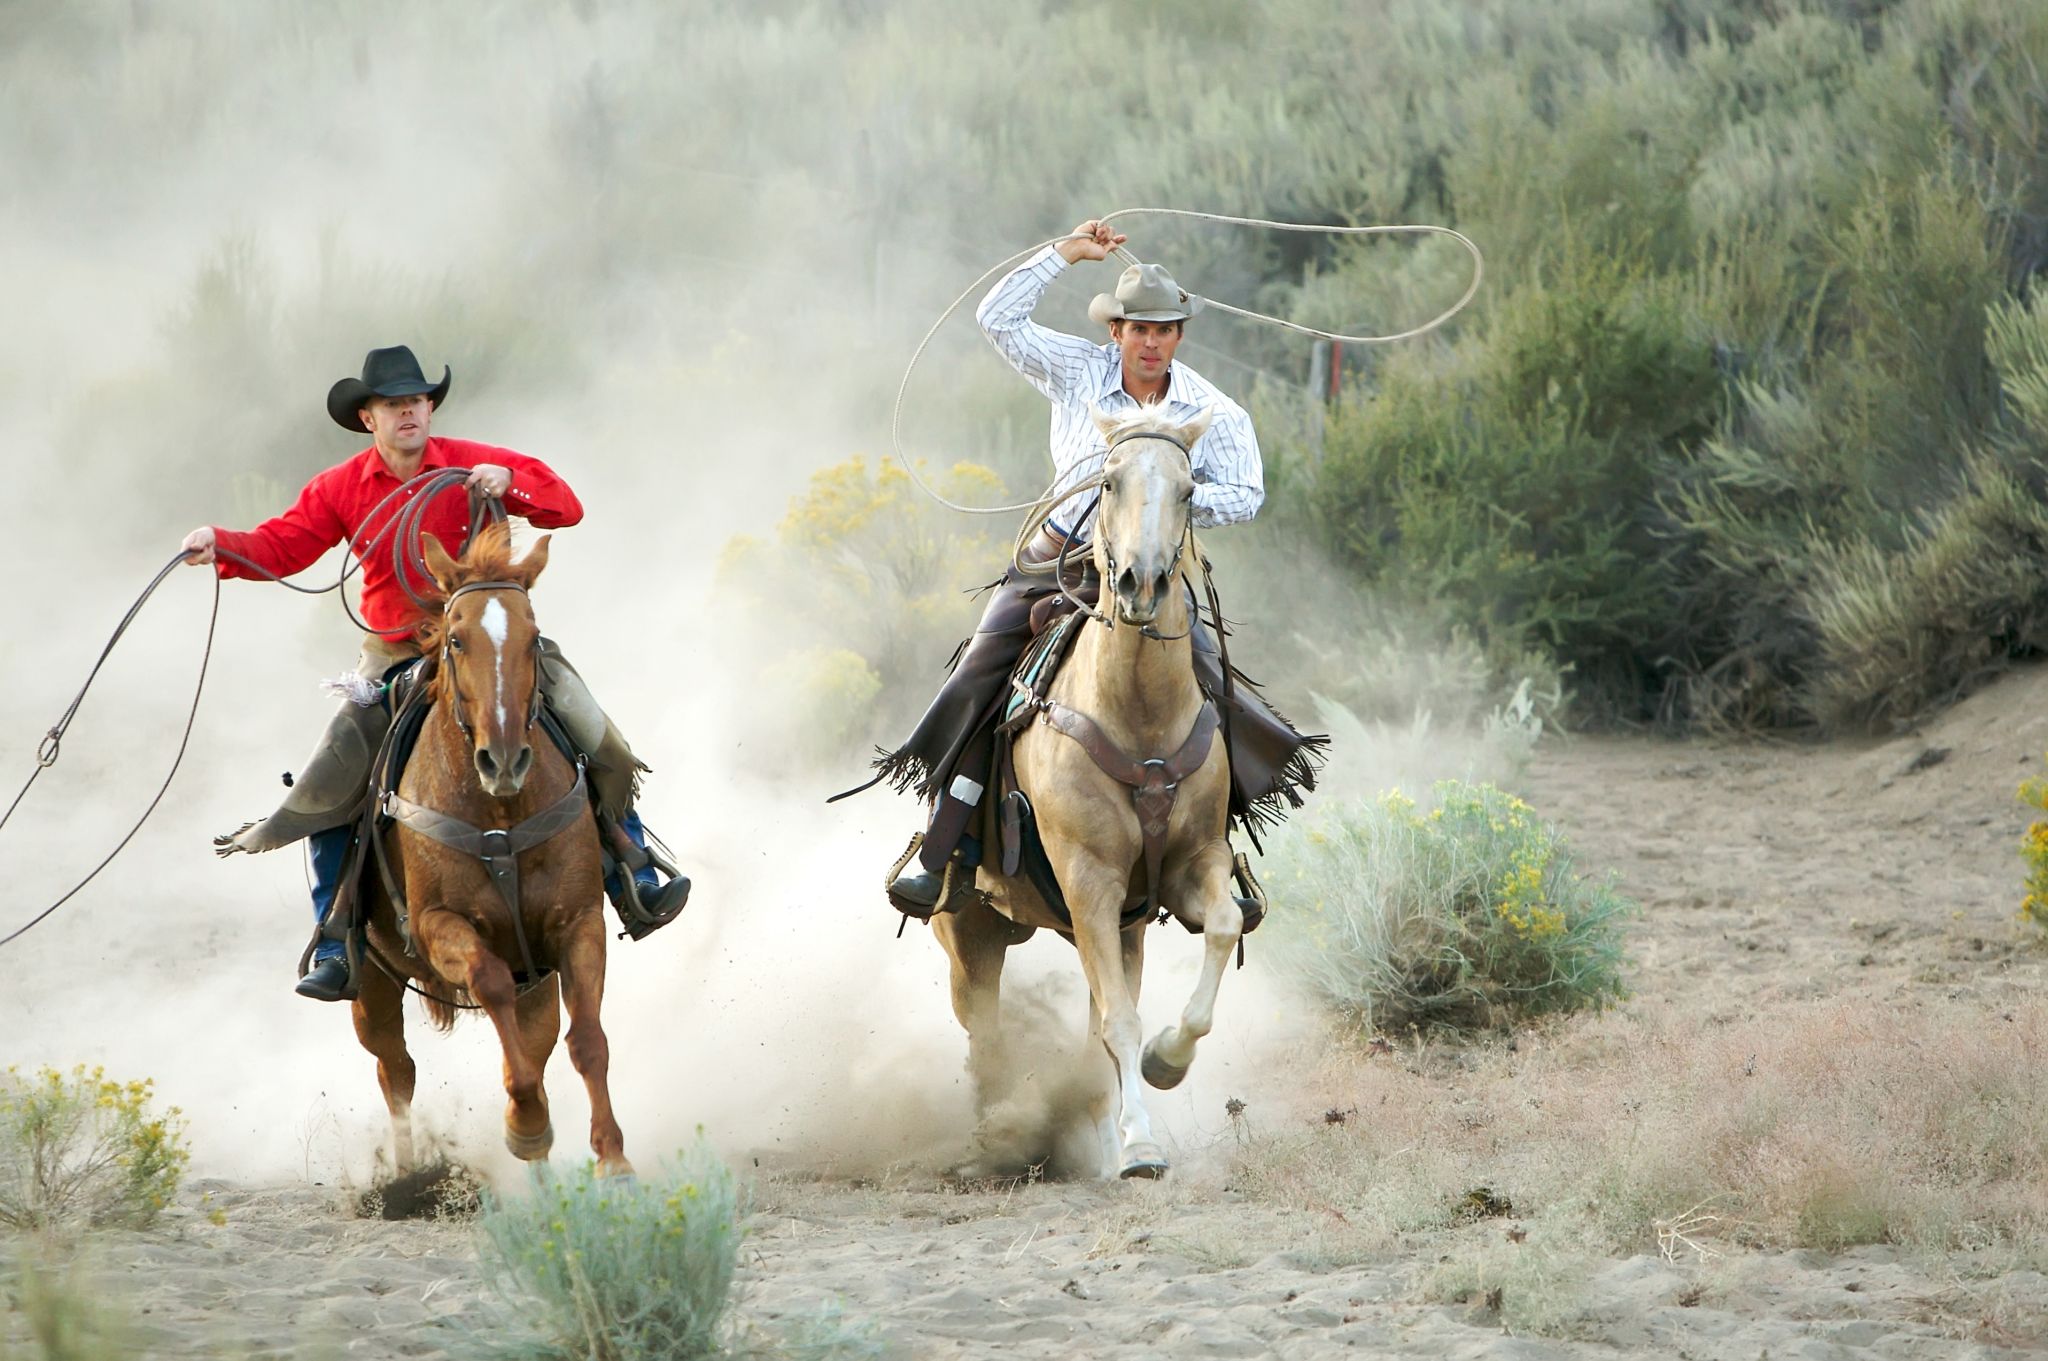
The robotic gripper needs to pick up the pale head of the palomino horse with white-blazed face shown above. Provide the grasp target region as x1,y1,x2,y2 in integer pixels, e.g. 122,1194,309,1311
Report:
1096,411,1208,624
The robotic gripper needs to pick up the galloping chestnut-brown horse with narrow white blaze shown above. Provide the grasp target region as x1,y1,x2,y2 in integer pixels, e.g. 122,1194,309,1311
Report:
354,524,633,1173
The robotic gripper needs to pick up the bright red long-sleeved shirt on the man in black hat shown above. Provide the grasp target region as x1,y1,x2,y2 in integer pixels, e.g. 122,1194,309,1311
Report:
213,436,584,639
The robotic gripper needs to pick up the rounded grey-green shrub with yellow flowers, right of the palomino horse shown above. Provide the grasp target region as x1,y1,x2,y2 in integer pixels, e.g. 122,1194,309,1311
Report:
1272,780,1634,1029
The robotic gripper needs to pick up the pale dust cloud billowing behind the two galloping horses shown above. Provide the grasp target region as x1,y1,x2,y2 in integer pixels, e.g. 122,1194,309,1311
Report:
0,0,1441,1181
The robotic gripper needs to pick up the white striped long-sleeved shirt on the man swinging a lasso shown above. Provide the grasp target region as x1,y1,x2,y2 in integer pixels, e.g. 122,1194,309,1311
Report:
975,246,1266,534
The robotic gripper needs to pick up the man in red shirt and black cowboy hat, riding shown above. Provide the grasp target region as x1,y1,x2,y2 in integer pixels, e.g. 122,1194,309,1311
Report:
184,346,690,1001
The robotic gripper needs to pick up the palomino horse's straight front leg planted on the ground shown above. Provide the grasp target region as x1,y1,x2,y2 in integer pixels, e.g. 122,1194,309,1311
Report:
1047,845,1167,1177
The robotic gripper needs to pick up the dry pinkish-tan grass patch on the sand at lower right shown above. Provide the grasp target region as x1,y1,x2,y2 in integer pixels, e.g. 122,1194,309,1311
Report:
1235,1005,2048,1261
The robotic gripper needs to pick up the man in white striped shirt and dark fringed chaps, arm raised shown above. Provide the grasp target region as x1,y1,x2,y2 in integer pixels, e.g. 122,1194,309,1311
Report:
877,221,1327,915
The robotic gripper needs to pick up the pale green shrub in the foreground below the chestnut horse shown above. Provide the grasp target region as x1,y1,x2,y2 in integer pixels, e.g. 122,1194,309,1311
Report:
465,1140,741,1361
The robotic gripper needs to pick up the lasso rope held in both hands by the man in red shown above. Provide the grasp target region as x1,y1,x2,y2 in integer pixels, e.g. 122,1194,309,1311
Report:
0,469,506,948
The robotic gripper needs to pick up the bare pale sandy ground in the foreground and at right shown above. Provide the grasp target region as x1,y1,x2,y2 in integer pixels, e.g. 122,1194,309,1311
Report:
4,671,2048,1361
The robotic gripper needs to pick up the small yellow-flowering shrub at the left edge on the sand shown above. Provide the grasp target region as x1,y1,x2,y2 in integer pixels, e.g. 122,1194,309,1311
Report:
0,1064,193,1228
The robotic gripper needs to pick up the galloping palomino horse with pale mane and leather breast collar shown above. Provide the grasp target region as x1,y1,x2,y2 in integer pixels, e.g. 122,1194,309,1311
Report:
932,413,1243,1177
